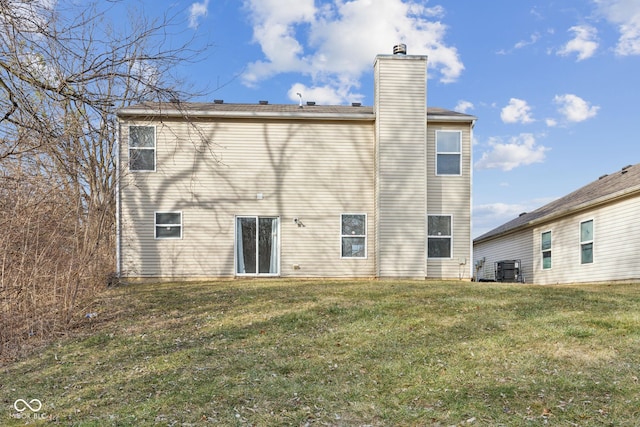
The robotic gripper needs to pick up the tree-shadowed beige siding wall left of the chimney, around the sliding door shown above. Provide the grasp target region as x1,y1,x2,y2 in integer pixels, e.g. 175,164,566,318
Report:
121,119,376,277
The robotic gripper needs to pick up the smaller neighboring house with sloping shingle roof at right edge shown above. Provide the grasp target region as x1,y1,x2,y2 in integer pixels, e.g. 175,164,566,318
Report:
473,164,640,285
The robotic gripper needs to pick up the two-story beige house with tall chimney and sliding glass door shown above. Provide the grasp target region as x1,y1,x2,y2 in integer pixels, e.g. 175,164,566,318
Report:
117,46,475,280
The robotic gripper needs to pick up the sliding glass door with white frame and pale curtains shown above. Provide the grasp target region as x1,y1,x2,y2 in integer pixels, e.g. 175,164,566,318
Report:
236,216,279,276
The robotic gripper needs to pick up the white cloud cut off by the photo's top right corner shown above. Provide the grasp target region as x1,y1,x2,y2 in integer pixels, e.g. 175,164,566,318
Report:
595,0,640,56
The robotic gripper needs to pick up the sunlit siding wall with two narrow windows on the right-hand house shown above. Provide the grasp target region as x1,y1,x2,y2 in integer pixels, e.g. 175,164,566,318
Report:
533,196,640,284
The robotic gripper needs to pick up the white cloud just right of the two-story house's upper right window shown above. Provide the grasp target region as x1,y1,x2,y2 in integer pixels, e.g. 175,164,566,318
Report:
474,133,550,171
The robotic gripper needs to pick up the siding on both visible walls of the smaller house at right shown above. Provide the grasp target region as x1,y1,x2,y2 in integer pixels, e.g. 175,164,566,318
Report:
474,195,640,285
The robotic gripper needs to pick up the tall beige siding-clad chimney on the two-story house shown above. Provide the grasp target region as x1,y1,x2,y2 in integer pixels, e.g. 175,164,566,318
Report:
374,55,427,278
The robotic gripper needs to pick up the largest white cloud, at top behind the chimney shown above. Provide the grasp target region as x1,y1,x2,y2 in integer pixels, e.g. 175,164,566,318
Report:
243,0,464,102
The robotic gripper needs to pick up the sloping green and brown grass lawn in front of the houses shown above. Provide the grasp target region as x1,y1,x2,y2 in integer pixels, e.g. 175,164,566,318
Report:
0,280,640,426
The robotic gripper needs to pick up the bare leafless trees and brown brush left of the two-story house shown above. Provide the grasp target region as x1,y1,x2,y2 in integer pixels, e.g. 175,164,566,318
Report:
0,0,208,353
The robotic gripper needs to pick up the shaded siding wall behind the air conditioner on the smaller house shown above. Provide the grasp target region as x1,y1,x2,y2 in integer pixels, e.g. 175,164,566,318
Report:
473,229,540,283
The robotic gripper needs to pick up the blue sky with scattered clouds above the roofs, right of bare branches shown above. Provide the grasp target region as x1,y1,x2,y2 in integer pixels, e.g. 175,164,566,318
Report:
132,0,640,237
